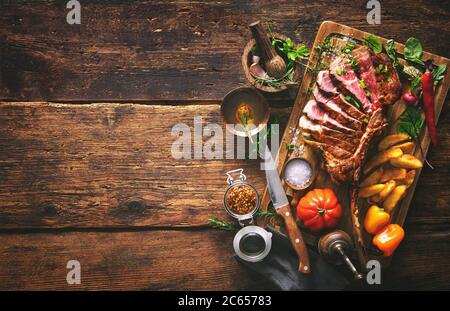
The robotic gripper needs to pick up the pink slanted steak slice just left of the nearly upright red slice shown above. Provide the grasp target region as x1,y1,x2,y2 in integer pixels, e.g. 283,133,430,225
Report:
330,56,373,113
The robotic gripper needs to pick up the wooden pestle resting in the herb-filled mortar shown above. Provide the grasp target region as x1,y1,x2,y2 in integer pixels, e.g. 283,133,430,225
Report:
249,21,287,79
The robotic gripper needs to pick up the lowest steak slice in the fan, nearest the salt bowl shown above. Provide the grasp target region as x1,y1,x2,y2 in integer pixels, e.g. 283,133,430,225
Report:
299,115,358,152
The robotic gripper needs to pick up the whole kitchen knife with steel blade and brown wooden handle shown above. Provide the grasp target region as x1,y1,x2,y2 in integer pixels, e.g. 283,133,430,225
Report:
264,146,311,273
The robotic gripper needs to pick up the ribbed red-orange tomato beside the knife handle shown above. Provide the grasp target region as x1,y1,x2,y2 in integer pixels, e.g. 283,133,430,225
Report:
297,188,342,232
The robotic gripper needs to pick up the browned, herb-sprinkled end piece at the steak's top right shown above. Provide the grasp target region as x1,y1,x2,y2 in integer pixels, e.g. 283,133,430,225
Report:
372,53,402,105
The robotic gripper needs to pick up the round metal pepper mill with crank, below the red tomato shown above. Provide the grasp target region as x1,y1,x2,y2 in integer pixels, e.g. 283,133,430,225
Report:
318,230,364,280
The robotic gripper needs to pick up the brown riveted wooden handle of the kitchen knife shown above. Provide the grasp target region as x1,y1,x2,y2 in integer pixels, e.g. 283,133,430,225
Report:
277,204,311,273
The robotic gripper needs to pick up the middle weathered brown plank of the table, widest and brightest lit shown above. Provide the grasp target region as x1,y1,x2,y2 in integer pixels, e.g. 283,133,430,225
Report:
0,103,287,229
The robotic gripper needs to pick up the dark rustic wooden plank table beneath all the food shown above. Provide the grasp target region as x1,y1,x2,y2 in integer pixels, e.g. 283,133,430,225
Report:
0,0,450,290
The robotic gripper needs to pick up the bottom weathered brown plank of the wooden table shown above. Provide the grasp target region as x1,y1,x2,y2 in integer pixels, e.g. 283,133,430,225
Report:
0,227,450,290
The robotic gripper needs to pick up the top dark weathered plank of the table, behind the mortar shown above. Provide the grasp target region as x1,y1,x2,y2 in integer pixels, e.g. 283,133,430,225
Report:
0,0,450,100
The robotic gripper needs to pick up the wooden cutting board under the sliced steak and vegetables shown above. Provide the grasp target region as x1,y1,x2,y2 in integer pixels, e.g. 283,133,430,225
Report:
261,21,450,267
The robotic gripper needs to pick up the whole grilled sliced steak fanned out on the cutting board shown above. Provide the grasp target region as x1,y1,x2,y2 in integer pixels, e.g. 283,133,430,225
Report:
299,47,401,183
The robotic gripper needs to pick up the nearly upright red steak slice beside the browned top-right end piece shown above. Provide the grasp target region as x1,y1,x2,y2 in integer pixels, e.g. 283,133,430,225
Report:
352,46,380,109
